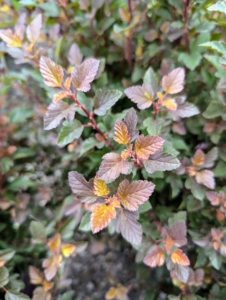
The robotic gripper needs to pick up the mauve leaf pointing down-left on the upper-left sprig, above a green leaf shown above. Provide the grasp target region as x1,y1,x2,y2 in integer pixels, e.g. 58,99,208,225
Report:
44,101,75,130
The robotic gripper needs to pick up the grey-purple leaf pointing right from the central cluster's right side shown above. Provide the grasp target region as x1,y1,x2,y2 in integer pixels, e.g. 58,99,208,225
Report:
144,151,180,174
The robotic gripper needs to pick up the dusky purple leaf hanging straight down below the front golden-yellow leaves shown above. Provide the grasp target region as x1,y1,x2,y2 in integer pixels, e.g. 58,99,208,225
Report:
114,209,142,246
